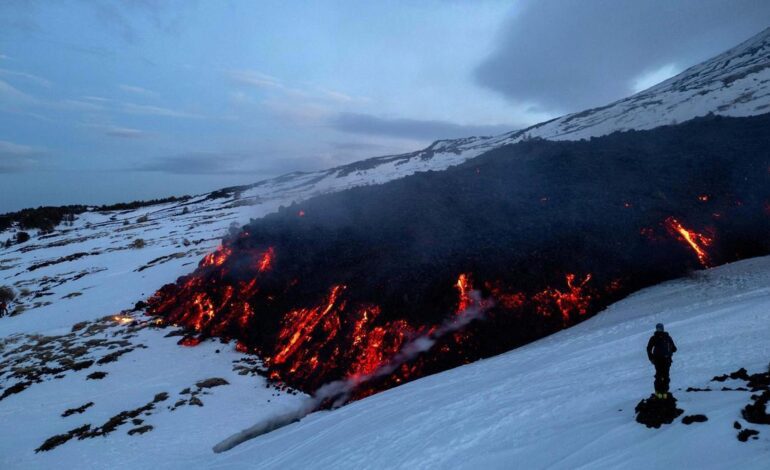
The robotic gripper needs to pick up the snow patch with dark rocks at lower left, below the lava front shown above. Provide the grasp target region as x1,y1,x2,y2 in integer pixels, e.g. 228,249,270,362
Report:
0,320,306,469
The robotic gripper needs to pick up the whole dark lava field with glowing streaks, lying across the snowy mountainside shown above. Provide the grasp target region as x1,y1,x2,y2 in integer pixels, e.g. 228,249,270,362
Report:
148,114,770,394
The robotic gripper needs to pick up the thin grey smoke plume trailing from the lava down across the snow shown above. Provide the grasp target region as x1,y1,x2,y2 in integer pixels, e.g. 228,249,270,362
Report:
213,290,494,453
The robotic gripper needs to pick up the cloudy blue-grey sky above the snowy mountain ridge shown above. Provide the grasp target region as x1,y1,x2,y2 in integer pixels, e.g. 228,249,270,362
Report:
0,0,770,212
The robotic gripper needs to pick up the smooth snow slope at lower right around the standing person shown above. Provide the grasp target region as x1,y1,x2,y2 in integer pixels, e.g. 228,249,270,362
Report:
213,258,770,469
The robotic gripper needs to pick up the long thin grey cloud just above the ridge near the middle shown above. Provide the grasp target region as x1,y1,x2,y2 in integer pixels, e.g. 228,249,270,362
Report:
329,113,515,140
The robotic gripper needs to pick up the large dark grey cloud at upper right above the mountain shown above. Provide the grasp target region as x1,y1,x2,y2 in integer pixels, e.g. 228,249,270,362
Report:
475,0,770,112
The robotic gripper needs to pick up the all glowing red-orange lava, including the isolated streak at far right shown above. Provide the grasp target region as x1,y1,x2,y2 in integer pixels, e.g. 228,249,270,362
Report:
148,213,728,398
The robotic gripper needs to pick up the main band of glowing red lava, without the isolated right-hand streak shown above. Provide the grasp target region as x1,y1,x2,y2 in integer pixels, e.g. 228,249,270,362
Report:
148,237,598,397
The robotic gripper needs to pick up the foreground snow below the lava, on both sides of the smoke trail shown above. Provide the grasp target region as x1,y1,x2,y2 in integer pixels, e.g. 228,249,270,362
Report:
0,257,770,469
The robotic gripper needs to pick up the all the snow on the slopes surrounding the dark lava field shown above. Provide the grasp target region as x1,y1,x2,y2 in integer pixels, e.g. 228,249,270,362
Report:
0,25,770,468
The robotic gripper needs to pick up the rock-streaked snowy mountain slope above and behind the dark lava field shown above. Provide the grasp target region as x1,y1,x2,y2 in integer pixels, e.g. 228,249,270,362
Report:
0,29,770,334
